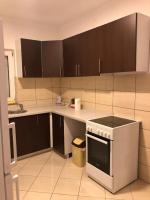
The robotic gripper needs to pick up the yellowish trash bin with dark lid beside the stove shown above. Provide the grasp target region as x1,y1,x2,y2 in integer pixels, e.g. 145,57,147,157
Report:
72,136,85,167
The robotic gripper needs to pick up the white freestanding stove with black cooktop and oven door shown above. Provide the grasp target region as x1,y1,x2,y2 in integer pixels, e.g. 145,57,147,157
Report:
86,116,139,193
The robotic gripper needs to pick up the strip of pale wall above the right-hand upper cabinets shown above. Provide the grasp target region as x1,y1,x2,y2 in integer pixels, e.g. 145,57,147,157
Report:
59,0,150,39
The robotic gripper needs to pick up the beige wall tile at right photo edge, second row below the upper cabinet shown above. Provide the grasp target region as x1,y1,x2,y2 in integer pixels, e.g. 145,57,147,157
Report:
135,92,150,111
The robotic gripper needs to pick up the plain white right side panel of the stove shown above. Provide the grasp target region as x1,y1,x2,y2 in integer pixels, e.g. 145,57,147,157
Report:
113,123,139,191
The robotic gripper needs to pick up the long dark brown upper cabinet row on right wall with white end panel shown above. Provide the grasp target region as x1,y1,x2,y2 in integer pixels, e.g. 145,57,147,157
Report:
64,13,150,76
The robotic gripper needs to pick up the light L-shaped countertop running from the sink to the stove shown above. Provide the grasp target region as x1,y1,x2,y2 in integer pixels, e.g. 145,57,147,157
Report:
8,105,111,122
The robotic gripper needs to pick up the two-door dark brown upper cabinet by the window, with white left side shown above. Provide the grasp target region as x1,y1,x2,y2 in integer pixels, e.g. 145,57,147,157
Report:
17,39,63,77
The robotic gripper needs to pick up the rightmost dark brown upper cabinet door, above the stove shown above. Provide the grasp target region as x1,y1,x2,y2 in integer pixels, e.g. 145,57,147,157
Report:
99,14,136,73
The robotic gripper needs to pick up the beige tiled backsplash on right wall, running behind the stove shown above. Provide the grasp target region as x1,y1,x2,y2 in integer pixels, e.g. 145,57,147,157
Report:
60,74,150,182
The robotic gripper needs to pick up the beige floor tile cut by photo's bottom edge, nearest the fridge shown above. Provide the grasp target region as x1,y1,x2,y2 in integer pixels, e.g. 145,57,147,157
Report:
24,192,51,200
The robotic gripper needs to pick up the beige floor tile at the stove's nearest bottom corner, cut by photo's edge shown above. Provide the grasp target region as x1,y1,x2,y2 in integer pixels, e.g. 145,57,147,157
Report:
106,186,133,200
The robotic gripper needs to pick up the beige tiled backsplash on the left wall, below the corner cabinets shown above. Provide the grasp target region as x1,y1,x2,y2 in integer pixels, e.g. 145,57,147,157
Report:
16,78,60,108
